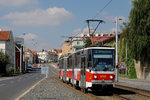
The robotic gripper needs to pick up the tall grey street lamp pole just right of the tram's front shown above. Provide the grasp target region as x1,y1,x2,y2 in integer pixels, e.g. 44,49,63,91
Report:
115,16,122,82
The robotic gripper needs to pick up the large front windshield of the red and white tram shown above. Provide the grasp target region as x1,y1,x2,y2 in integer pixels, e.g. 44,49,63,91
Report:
92,50,114,71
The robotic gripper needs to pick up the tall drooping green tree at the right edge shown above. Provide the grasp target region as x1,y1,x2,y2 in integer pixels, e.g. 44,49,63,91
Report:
127,0,150,62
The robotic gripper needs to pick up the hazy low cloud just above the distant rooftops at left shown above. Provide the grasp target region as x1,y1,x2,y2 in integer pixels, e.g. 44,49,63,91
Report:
20,33,51,51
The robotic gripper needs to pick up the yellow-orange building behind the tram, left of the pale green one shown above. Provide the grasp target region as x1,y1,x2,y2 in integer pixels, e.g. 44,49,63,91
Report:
62,42,72,56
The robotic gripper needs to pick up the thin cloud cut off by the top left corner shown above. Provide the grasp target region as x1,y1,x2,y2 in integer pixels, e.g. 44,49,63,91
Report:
0,0,38,7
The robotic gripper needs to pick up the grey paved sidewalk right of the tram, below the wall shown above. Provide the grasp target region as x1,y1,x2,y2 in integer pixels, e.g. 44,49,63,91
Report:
116,77,150,91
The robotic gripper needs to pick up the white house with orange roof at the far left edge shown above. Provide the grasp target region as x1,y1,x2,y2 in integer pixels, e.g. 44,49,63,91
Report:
0,31,15,66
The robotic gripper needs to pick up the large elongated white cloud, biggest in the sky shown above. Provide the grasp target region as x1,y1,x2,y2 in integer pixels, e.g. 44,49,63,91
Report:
3,7,73,26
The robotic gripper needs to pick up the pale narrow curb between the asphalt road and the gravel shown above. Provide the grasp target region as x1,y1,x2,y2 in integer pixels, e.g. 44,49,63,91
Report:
15,77,46,100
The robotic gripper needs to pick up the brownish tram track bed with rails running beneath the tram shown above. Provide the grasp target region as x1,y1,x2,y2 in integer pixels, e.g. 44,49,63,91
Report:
47,63,150,100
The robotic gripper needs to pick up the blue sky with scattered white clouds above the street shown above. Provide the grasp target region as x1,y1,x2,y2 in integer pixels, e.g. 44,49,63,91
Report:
0,0,132,51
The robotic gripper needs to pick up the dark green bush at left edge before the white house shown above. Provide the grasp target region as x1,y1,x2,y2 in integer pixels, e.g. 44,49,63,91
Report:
0,51,9,73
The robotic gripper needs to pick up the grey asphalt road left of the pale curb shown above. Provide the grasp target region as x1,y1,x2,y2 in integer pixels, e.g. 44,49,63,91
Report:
0,67,44,100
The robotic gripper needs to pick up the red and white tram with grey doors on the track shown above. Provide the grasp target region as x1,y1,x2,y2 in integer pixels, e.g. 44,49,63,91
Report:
59,47,115,91
